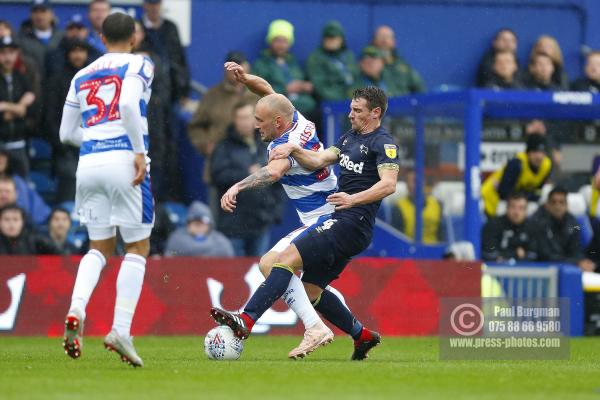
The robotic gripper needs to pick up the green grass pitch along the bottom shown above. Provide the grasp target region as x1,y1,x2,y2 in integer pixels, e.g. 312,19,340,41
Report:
0,336,600,400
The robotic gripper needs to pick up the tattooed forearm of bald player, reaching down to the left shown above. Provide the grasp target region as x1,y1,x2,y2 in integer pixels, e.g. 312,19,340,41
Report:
221,160,290,212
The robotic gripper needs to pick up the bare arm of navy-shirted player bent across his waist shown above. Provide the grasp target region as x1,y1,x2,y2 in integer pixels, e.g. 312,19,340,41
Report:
327,168,398,210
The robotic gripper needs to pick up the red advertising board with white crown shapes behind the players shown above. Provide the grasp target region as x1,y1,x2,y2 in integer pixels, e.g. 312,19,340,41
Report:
0,256,481,336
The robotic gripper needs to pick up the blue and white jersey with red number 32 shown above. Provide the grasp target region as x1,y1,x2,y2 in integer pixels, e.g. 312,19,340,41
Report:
65,53,154,165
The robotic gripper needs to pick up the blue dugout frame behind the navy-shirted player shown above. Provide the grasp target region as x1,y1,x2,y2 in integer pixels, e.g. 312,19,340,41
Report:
321,89,600,258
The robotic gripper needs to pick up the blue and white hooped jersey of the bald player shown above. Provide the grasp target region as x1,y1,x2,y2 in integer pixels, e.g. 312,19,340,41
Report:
268,111,337,226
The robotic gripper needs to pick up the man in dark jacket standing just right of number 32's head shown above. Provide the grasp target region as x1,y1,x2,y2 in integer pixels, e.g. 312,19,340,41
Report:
141,0,190,103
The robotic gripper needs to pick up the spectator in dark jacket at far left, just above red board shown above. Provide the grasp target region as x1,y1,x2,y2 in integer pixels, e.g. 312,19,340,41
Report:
0,205,59,255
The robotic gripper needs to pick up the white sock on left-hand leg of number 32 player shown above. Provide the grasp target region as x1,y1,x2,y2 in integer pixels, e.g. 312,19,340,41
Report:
69,249,106,319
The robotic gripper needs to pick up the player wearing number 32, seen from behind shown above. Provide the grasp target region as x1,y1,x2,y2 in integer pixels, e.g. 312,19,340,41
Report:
60,13,154,367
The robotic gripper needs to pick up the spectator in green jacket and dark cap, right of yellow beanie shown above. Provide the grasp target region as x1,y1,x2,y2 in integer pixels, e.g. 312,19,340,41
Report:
306,21,358,101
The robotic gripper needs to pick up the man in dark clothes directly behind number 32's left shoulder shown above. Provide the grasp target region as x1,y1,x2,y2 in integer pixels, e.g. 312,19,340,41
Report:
44,39,92,203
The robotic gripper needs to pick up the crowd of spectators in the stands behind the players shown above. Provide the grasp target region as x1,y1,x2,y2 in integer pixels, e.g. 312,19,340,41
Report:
0,0,600,269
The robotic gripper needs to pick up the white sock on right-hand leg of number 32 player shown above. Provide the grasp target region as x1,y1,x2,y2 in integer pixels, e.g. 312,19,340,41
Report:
113,253,146,338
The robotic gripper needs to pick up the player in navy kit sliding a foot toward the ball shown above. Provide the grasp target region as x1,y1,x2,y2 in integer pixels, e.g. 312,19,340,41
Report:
213,86,399,360
